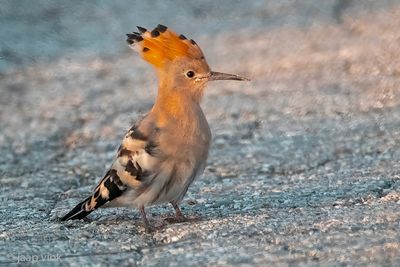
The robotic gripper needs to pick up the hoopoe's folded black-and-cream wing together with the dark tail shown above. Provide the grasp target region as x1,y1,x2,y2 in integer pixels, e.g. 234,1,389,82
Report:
61,122,162,221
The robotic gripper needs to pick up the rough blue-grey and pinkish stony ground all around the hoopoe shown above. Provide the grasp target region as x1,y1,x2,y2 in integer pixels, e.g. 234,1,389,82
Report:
0,1,400,266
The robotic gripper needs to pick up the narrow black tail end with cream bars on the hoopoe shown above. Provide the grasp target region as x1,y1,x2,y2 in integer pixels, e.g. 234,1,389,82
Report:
61,169,126,221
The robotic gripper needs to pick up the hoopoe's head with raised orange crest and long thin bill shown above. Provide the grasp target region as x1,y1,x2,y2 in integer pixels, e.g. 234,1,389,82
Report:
127,24,249,99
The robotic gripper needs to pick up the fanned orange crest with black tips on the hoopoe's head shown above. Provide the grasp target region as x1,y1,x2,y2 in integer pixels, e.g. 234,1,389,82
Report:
126,24,203,68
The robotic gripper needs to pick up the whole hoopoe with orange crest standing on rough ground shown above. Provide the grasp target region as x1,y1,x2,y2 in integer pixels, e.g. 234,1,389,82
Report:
61,24,249,232
